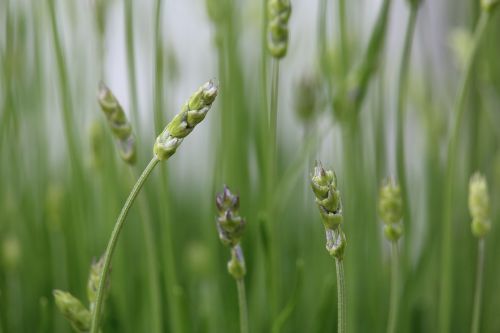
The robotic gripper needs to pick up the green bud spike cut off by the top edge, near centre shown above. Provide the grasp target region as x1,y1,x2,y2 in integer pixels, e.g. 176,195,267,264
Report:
267,0,292,59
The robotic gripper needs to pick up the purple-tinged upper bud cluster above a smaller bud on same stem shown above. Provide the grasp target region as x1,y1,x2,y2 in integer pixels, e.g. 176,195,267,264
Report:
215,186,246,247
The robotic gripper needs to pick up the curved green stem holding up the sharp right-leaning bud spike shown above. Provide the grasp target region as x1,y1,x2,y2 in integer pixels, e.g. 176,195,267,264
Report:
90,155,159,333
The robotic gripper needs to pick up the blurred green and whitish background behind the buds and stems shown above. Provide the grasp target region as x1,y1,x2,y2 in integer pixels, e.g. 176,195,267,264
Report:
0,0,500,332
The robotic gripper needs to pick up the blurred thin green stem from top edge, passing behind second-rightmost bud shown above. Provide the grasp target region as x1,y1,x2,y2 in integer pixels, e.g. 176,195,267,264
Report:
396,5,418,270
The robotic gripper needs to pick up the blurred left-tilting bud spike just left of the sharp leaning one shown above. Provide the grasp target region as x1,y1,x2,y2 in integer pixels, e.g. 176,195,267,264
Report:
97,81,136,164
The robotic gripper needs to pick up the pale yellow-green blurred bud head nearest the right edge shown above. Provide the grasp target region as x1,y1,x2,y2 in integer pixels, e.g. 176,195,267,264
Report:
469,173,491,238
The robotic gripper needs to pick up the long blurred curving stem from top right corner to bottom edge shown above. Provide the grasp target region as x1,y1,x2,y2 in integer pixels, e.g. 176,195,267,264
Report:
439,10,491,333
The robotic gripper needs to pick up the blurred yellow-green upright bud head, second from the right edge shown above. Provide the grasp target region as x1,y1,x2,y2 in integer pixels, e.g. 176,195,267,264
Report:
378,180,403,242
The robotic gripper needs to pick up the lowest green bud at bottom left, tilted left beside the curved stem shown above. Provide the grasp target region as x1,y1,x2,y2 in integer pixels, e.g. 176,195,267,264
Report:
53,290,91,332
